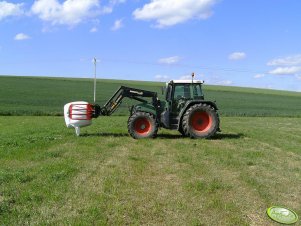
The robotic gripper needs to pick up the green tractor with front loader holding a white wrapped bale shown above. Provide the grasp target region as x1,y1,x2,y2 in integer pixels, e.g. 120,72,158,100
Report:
64,75,220,139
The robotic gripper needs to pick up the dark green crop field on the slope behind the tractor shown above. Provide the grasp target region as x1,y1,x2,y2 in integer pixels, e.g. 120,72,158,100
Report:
0,76,301,117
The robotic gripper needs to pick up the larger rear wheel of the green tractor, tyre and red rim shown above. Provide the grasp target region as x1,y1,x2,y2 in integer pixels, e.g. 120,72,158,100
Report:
182,104,219,138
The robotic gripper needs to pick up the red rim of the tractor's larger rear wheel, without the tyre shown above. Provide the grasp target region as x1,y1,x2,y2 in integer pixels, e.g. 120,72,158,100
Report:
191,111,212,133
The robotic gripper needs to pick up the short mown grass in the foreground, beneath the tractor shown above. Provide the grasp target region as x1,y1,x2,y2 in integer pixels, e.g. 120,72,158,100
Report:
0,116,301,225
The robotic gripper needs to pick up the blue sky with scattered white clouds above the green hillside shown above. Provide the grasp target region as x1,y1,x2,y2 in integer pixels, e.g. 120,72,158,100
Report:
0,0,301,92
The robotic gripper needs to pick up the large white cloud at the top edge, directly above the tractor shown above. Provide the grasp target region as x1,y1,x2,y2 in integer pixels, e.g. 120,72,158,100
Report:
133,0,217,28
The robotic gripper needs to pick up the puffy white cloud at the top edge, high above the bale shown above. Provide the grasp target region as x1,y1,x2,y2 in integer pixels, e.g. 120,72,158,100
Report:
31,0,100,26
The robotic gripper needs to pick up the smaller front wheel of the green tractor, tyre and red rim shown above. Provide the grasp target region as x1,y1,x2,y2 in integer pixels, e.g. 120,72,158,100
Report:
128,112,158,139
